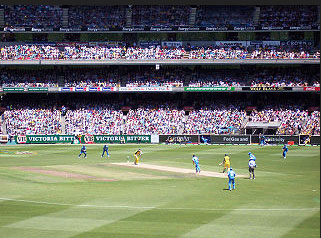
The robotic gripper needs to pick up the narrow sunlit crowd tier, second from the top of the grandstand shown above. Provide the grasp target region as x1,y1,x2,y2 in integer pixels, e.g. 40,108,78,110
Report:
0,45,320,60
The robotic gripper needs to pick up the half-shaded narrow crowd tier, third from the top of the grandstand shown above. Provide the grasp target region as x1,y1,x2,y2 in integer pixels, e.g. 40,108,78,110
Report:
0,66,320,87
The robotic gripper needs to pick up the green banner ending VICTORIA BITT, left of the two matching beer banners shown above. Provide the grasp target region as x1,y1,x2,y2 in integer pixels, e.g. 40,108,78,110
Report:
15,135,75,144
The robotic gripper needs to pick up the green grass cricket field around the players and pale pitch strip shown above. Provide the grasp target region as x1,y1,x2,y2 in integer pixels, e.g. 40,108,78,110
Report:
0,145,320,238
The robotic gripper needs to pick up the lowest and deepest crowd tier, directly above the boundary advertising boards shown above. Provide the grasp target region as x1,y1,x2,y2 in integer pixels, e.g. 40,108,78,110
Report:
4,93,320,135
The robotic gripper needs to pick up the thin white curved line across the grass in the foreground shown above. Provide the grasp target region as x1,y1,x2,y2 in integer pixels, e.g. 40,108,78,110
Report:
0,198,320,211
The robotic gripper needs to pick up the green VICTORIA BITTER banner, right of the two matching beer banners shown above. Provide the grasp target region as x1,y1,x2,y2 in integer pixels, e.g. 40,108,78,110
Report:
81,135,151,144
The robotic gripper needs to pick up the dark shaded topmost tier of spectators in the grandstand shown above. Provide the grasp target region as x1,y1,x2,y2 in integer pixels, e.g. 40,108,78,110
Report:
4,5,320,30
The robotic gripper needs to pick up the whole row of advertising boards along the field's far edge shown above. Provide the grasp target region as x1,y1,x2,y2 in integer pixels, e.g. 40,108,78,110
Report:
14,135,320,145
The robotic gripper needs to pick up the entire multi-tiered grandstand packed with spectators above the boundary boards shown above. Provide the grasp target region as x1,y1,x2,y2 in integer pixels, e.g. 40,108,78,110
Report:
0,5,320,145
